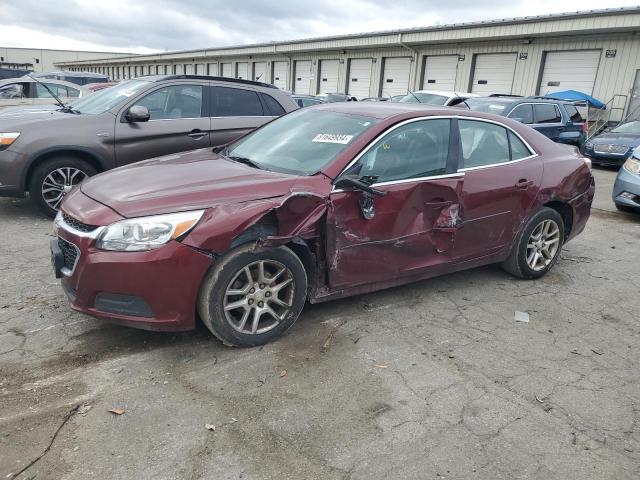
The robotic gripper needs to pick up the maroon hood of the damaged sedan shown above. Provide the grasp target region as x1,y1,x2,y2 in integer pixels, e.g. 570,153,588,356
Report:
80,149,299,217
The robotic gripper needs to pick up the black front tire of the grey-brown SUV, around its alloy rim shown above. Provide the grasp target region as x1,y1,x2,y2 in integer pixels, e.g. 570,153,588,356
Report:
29,157,98,218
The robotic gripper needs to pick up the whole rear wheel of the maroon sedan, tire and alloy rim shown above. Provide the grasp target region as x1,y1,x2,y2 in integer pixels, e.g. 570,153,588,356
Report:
502,207,565,279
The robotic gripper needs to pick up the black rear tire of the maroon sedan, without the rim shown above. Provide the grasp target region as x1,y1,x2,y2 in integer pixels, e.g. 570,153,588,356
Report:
501,207,565,279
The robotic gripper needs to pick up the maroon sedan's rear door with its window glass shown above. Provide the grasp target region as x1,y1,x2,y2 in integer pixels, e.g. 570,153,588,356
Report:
454,119,543,262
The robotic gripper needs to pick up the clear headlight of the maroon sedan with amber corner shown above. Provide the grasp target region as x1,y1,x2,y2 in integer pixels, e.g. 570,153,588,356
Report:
96,210,204,252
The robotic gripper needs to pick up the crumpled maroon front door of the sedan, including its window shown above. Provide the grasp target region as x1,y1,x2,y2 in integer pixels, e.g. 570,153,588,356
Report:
327,118,464,289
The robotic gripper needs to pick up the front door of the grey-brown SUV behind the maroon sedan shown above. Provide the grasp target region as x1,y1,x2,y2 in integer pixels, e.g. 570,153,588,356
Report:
115,82,211,165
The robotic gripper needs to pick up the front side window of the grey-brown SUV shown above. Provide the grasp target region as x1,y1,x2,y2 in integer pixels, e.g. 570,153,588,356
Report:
136,85,202,120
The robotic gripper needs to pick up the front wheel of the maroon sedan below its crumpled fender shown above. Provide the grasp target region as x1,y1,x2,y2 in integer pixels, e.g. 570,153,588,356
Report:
198,243,307,347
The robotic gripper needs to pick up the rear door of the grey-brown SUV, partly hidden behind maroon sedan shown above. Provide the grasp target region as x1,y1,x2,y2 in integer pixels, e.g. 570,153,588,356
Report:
211,85,277,146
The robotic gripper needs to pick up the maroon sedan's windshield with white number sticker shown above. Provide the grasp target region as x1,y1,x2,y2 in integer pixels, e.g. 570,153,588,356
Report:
225,109,378,175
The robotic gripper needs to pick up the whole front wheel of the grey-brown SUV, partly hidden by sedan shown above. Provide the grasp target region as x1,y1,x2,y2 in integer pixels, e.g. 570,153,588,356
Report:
29,157,97,218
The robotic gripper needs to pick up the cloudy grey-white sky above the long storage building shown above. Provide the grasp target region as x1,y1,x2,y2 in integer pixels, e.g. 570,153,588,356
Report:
0,0,640,53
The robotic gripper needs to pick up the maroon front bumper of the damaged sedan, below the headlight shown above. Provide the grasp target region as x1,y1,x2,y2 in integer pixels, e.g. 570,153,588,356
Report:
57,228,211,331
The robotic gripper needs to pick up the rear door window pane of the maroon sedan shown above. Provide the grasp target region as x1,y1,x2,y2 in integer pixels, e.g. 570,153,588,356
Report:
458,120,510,168
